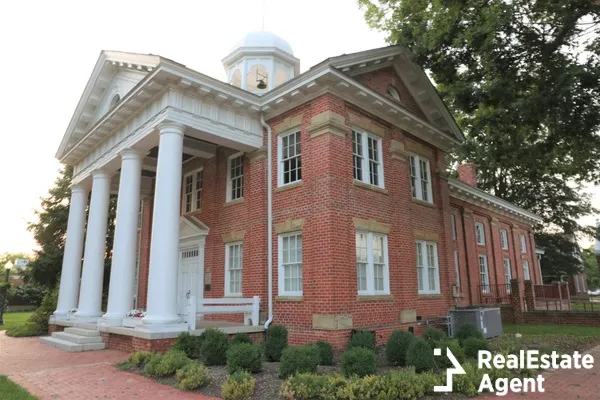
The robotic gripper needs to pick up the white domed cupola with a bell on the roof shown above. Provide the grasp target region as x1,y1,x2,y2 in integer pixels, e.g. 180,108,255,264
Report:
222,32,300,94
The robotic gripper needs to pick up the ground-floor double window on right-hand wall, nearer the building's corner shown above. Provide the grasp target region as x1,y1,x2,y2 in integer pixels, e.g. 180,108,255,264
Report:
356,232,390,295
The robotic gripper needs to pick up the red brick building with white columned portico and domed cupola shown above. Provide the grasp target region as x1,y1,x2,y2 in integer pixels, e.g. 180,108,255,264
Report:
51,32,541,348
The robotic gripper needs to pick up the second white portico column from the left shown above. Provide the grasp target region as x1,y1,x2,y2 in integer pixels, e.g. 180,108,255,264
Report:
75,170,110,320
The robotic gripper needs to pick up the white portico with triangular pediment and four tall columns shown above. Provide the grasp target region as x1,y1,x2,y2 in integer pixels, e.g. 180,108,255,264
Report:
52,52,263,333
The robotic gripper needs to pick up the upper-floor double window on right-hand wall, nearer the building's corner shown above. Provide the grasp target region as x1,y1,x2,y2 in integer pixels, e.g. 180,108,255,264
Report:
352,128,383,187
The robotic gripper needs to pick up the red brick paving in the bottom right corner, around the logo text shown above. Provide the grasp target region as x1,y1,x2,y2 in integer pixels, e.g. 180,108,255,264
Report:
485,346,600,400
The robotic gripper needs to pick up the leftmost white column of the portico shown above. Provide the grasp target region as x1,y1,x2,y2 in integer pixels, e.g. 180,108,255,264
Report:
54,186,88,319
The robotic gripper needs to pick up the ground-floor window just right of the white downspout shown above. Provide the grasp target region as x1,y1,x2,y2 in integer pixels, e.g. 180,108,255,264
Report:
278,232,302,296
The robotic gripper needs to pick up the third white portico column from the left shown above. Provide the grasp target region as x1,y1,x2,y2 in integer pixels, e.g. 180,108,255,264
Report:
102,149,143,325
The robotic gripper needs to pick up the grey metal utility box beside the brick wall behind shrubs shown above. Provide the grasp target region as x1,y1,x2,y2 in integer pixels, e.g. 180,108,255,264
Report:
450,308,502,339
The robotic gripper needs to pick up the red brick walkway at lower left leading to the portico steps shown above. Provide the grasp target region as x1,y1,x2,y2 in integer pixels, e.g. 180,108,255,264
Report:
0,331,220,400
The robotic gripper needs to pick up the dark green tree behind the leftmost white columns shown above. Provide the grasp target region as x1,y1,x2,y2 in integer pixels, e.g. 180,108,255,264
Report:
27,166,116,291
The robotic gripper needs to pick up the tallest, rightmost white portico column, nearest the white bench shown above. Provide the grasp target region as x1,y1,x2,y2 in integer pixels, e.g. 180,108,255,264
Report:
144,122,184,324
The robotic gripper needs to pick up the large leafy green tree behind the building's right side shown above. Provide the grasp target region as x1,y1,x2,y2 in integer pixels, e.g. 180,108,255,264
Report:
359,0,600,278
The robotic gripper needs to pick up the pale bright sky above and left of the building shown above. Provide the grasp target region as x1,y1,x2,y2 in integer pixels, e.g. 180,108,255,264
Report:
0,0,600,253
